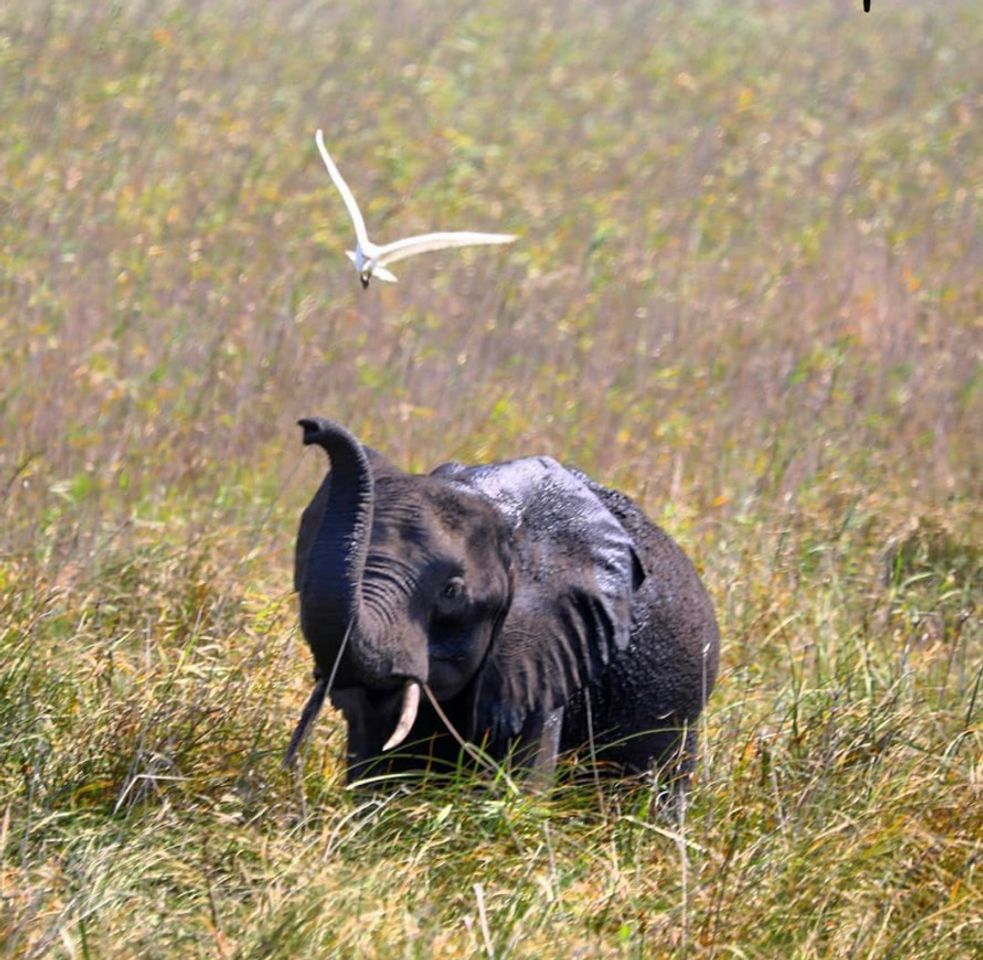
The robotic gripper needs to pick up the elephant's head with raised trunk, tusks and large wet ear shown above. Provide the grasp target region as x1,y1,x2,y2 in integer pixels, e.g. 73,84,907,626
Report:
288,419,642,760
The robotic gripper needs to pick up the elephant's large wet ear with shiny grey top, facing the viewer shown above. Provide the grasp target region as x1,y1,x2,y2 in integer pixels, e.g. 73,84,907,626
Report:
450,457,644,742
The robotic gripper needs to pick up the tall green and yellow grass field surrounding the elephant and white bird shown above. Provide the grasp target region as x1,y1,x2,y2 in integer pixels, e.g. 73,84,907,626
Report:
0,0,983,960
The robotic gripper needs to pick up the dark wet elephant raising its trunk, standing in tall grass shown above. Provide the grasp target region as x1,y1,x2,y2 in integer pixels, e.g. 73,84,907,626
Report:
284,418,719,791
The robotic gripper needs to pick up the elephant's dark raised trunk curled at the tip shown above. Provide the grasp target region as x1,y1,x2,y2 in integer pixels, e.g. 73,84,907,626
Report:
297,418,374,678
